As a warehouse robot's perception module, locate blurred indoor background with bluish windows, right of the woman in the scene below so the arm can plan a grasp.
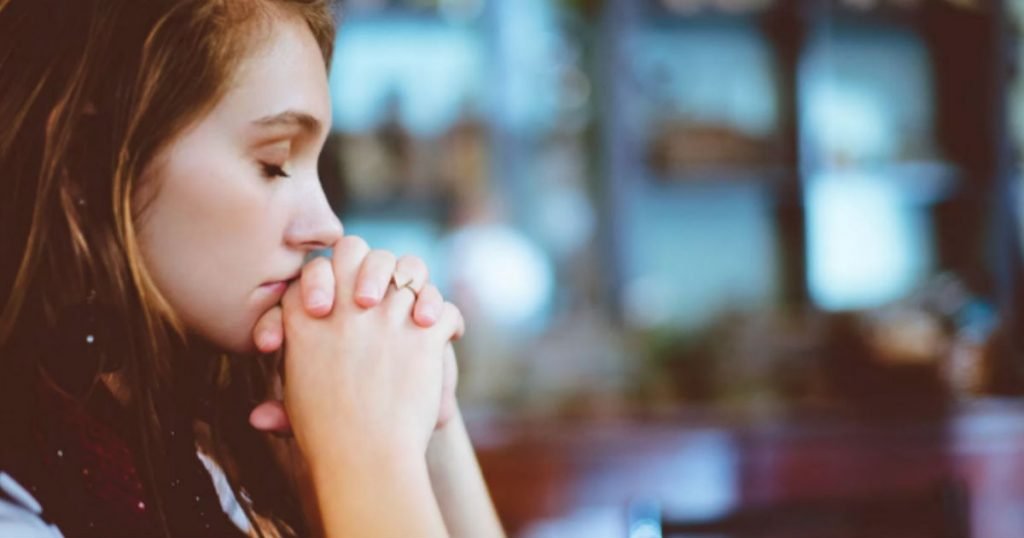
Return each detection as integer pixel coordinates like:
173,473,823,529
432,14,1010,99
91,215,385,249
322,0,1024,538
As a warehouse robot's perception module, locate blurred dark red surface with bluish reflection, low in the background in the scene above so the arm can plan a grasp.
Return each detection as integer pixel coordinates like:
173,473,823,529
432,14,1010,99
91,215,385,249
470,403,1024,538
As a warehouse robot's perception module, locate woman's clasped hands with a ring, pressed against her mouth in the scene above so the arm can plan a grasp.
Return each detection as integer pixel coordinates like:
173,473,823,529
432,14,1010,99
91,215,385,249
241,236,465,449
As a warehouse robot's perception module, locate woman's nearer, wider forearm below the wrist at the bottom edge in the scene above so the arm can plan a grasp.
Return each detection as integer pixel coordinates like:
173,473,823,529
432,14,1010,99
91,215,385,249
312,444,449,538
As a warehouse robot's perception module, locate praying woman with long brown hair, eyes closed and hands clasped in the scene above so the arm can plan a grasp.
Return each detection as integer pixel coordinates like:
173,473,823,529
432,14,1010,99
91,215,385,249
0,0,502,537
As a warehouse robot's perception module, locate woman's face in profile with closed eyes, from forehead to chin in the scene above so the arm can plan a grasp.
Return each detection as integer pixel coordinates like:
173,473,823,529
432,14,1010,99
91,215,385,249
137,13,341,353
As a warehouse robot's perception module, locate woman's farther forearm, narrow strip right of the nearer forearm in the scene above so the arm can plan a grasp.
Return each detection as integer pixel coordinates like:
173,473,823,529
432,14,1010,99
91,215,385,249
427,413,505,538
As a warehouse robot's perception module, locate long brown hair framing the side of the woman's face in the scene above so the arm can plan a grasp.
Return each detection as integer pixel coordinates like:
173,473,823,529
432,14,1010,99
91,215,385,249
0,0,335,528
